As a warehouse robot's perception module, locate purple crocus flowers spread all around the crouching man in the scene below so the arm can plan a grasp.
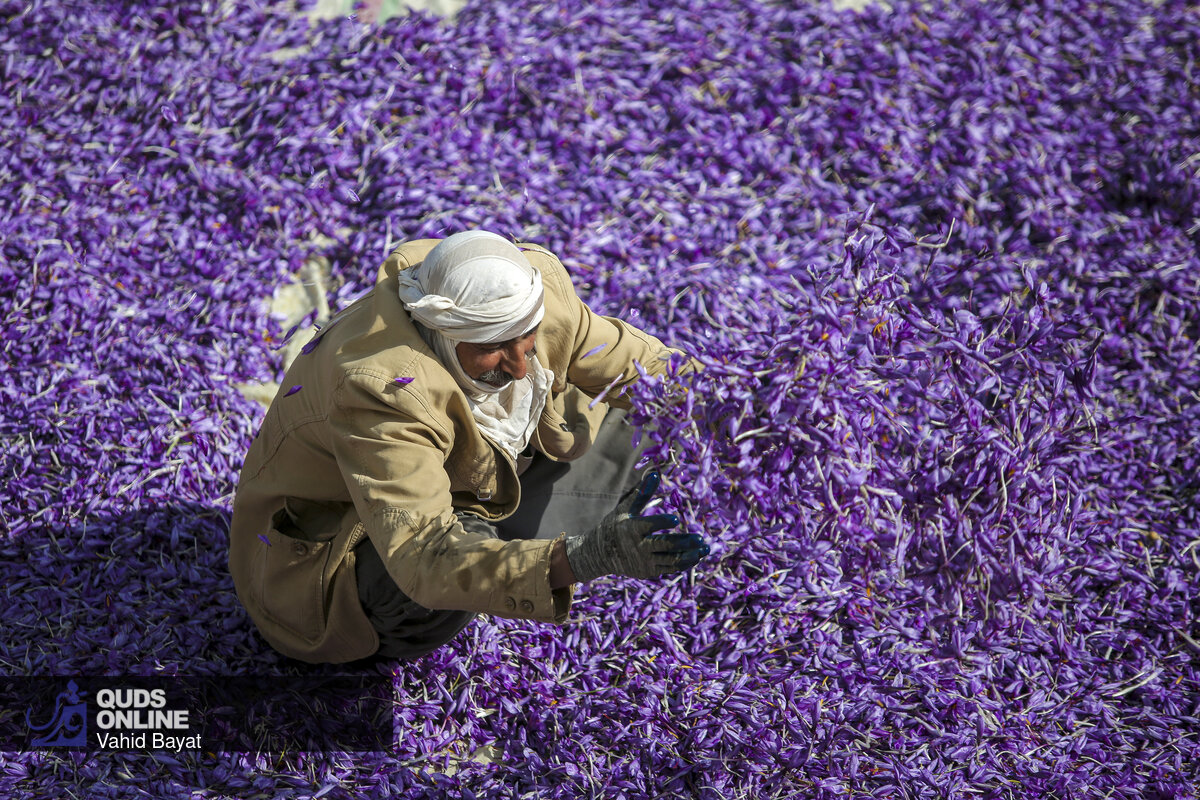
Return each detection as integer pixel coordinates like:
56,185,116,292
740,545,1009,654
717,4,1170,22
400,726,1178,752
0,0,1200,800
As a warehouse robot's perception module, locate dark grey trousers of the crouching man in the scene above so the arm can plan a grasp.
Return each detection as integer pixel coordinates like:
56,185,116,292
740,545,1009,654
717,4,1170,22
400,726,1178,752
354,409,642,660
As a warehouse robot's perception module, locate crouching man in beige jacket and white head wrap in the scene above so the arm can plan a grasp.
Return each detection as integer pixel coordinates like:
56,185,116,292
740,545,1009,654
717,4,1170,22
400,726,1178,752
229,230,708,662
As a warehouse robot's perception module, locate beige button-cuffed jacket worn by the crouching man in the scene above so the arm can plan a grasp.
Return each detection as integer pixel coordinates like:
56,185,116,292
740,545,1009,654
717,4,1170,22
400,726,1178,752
229,240,672,662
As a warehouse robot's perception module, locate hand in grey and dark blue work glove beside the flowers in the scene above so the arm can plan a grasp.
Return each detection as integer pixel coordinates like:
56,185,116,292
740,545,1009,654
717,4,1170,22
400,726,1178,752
566,470,708,581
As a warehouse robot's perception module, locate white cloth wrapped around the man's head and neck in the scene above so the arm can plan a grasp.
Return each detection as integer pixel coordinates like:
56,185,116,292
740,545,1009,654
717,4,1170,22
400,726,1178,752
400,230,554,459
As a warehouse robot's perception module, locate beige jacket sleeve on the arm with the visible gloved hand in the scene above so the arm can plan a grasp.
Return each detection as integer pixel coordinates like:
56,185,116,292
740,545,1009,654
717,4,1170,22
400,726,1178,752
330,372,571,622
